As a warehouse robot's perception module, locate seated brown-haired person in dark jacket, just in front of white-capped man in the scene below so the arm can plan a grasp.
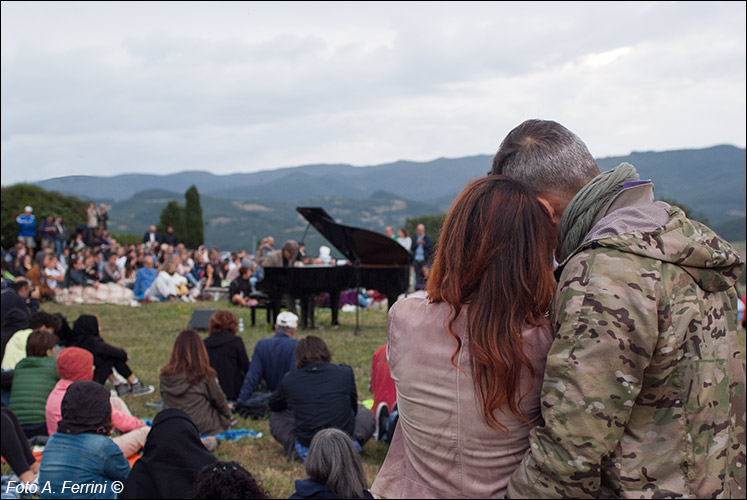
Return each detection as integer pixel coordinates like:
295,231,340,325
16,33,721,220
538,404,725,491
269,335,375,460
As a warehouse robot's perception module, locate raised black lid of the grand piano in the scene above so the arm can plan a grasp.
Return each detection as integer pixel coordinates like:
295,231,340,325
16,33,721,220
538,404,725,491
296,207,412,266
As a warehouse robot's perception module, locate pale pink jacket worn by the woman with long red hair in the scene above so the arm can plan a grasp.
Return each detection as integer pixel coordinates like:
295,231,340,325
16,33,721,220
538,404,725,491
371,295,552,498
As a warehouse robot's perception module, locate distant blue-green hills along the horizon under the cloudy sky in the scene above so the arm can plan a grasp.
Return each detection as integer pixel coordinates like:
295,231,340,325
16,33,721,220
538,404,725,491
23,146,747,252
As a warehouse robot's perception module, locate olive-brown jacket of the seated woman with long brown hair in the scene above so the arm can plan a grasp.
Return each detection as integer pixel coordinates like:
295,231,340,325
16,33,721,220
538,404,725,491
160,373,231,435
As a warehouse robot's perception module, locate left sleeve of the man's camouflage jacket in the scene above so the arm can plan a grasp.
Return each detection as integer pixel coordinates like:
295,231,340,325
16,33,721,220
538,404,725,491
507,249,660,498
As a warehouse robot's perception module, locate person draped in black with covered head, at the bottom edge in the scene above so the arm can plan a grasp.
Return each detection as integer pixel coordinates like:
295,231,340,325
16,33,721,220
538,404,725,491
119,408,218,499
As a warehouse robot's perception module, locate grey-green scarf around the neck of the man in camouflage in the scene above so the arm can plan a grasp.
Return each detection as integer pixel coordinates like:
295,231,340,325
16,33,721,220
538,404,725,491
557,162,638,262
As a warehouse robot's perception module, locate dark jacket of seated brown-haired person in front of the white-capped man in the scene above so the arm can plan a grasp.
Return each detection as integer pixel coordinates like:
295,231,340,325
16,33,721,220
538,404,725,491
269,362,358,446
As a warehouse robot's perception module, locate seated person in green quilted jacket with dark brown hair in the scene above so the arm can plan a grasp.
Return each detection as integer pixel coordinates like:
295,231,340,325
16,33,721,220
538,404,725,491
8,330,60,438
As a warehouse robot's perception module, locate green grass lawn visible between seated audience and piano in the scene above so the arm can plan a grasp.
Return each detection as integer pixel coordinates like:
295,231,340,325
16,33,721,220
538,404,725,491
36,302,387,498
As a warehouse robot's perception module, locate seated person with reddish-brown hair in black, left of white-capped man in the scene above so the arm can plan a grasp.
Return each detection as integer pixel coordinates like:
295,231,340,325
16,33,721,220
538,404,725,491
204,310,249,401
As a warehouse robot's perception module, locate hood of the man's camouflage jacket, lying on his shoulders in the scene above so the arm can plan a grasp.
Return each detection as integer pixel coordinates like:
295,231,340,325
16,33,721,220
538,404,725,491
574,203,744,292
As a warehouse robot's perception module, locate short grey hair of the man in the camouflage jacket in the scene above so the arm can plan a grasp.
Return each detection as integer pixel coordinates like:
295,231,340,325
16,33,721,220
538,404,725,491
489,120,599,197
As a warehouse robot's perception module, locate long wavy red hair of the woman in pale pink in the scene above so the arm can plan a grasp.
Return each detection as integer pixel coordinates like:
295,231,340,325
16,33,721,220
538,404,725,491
427,175,556,430
